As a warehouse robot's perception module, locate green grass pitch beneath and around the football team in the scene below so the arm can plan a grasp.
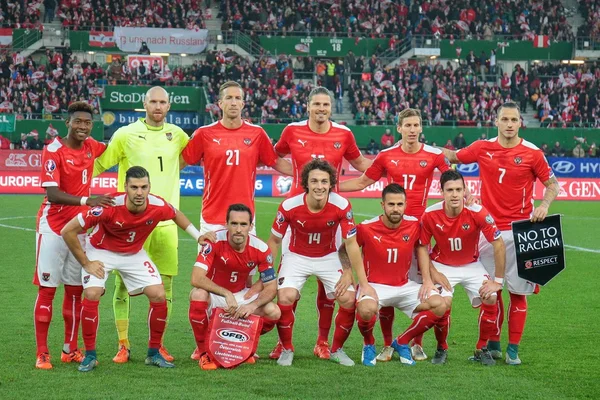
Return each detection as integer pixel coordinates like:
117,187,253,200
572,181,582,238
0,196,600,399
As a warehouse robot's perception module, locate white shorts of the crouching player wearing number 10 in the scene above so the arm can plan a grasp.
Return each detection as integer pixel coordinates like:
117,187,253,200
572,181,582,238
431,261,493,307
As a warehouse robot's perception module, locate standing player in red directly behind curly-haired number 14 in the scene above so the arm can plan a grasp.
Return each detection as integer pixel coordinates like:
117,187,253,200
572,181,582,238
270,87,371,359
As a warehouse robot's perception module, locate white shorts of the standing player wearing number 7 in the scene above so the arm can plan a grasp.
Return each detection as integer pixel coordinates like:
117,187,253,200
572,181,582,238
479,230,536,295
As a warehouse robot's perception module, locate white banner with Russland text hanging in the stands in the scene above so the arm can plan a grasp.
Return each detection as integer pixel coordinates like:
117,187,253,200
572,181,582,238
114,27,208,54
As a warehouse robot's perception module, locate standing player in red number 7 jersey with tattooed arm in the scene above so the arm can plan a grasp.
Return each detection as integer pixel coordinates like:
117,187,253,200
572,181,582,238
442,102,559,365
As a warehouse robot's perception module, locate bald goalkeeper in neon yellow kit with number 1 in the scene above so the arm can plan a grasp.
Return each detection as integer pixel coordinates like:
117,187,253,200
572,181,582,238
94,86,188,363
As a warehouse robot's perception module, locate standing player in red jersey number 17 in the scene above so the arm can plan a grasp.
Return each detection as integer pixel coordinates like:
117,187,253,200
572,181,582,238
340,108,450,361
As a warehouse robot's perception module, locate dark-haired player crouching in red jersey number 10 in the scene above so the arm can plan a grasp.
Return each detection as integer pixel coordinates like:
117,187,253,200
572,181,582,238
420,170,506,365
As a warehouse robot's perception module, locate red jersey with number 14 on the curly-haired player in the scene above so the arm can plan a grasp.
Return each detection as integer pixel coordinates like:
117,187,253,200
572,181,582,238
271,192,356,257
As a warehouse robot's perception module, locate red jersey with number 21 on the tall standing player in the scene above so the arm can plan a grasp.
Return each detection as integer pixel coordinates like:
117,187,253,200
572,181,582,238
181,121,278,225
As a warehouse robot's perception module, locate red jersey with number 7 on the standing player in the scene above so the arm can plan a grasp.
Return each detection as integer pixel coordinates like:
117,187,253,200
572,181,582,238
456,137,554,231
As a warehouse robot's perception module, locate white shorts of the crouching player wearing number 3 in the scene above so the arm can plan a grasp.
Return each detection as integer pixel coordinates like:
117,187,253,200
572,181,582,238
81,243,162,296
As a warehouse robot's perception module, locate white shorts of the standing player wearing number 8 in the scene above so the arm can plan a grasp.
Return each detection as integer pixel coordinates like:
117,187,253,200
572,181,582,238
35,232,85,287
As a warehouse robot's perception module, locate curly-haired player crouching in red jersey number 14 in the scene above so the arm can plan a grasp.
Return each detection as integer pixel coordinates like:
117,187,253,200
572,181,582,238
267,159,362,366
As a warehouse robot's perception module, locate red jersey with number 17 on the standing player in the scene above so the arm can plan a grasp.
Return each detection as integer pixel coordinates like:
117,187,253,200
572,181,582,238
365,144,450,217
